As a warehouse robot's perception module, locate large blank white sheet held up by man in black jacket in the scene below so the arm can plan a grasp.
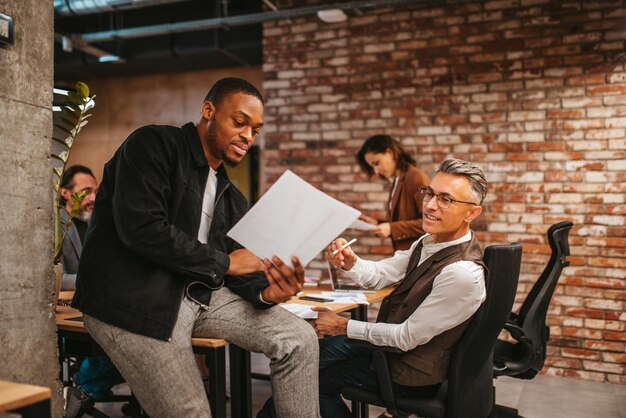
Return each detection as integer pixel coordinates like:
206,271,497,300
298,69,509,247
227,170,361,267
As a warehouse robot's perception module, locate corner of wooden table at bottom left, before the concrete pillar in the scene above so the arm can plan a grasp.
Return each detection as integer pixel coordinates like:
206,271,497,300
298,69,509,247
0,380,51,418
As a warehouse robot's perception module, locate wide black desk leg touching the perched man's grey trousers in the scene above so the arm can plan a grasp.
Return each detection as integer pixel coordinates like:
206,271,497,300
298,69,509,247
228,344,252,418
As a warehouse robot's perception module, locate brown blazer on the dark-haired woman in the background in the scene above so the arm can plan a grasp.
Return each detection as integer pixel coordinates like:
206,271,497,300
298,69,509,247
387,165,430,251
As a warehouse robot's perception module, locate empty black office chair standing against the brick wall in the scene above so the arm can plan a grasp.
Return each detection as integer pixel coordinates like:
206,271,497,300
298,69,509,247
493,222,573,379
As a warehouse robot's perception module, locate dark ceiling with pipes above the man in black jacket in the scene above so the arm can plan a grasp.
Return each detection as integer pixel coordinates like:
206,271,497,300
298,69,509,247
54,0,262,84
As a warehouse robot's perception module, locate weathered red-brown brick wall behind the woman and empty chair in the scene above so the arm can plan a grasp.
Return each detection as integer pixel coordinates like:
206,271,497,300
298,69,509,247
263,0,626,383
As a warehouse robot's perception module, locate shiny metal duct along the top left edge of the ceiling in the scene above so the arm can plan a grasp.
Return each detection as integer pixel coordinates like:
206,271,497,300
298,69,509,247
54,0,194,16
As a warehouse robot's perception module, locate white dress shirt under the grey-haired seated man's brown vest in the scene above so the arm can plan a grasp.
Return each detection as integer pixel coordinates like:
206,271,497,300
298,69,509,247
348,231,486,351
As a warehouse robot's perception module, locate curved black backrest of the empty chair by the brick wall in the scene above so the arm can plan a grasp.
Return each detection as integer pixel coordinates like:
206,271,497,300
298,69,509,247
517,221,573,371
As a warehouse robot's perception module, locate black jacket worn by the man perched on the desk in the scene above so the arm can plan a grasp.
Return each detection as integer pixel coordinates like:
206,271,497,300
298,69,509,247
72,123,271,340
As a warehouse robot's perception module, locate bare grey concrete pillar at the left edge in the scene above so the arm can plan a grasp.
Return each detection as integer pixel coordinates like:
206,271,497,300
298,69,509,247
0,0,62,417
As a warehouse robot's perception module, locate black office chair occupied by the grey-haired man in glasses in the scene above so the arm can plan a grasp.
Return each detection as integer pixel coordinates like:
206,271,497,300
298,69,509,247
341,243,522,418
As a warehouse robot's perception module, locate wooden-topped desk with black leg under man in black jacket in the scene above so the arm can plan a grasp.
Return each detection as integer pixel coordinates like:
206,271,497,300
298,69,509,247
56,304,229,418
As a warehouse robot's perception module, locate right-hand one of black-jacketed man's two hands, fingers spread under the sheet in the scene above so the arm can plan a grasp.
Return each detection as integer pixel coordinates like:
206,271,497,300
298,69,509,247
261,256,304,303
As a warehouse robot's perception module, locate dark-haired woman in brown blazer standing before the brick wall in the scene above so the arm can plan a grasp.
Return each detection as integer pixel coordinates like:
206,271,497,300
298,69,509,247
356,135,429,251
